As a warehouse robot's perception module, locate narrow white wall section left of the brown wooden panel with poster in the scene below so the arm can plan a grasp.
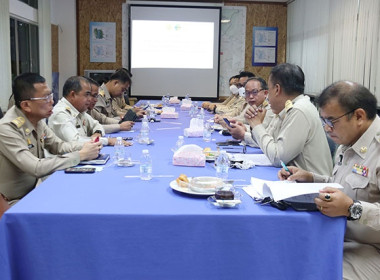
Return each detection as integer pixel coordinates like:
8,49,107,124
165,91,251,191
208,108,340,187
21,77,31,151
50,0,77,96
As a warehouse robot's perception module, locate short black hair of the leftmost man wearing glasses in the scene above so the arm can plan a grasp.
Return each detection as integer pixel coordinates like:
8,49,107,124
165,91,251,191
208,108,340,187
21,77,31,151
12,73,46,108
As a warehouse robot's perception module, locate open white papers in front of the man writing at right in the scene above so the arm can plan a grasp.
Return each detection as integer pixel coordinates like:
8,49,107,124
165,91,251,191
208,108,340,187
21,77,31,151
243,177,343,203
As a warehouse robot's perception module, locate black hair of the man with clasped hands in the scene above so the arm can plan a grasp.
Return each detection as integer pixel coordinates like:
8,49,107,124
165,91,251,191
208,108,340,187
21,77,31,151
269,63,305,95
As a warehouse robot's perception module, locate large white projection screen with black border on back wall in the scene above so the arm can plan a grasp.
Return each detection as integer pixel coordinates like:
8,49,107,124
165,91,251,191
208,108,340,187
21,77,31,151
129,4,221,99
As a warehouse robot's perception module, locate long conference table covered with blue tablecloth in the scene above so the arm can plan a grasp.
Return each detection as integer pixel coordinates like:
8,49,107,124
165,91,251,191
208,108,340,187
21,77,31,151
0,101,346,280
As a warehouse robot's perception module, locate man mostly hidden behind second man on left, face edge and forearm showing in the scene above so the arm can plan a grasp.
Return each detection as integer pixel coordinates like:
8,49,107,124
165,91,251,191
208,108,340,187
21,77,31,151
85,77,134,133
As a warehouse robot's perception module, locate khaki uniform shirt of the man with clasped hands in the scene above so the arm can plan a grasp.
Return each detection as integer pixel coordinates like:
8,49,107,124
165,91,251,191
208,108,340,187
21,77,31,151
252,95,332,175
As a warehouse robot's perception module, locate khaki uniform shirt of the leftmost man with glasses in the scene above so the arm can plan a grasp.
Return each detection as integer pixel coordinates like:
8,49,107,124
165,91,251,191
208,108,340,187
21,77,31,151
0,106,82,200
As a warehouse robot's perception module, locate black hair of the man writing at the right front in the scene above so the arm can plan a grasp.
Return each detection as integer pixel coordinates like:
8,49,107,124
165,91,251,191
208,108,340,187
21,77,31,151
317,81,377,120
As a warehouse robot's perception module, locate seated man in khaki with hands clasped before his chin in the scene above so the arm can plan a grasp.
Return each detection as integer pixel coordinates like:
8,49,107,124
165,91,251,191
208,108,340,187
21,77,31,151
245,63,332,175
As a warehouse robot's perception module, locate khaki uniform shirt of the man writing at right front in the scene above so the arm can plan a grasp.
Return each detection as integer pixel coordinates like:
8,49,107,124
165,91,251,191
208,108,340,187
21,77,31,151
313,116,380,249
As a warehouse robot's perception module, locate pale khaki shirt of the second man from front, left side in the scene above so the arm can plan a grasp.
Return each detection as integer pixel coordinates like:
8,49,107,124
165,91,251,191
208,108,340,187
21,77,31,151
49,97,108,145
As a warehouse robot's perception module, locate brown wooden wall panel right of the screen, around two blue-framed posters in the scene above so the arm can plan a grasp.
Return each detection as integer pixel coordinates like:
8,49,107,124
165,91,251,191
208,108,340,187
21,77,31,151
224,2,287,80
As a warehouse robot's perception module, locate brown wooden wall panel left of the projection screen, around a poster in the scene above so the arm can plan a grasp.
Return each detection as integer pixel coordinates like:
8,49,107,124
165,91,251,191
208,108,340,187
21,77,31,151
77,0,125,75
